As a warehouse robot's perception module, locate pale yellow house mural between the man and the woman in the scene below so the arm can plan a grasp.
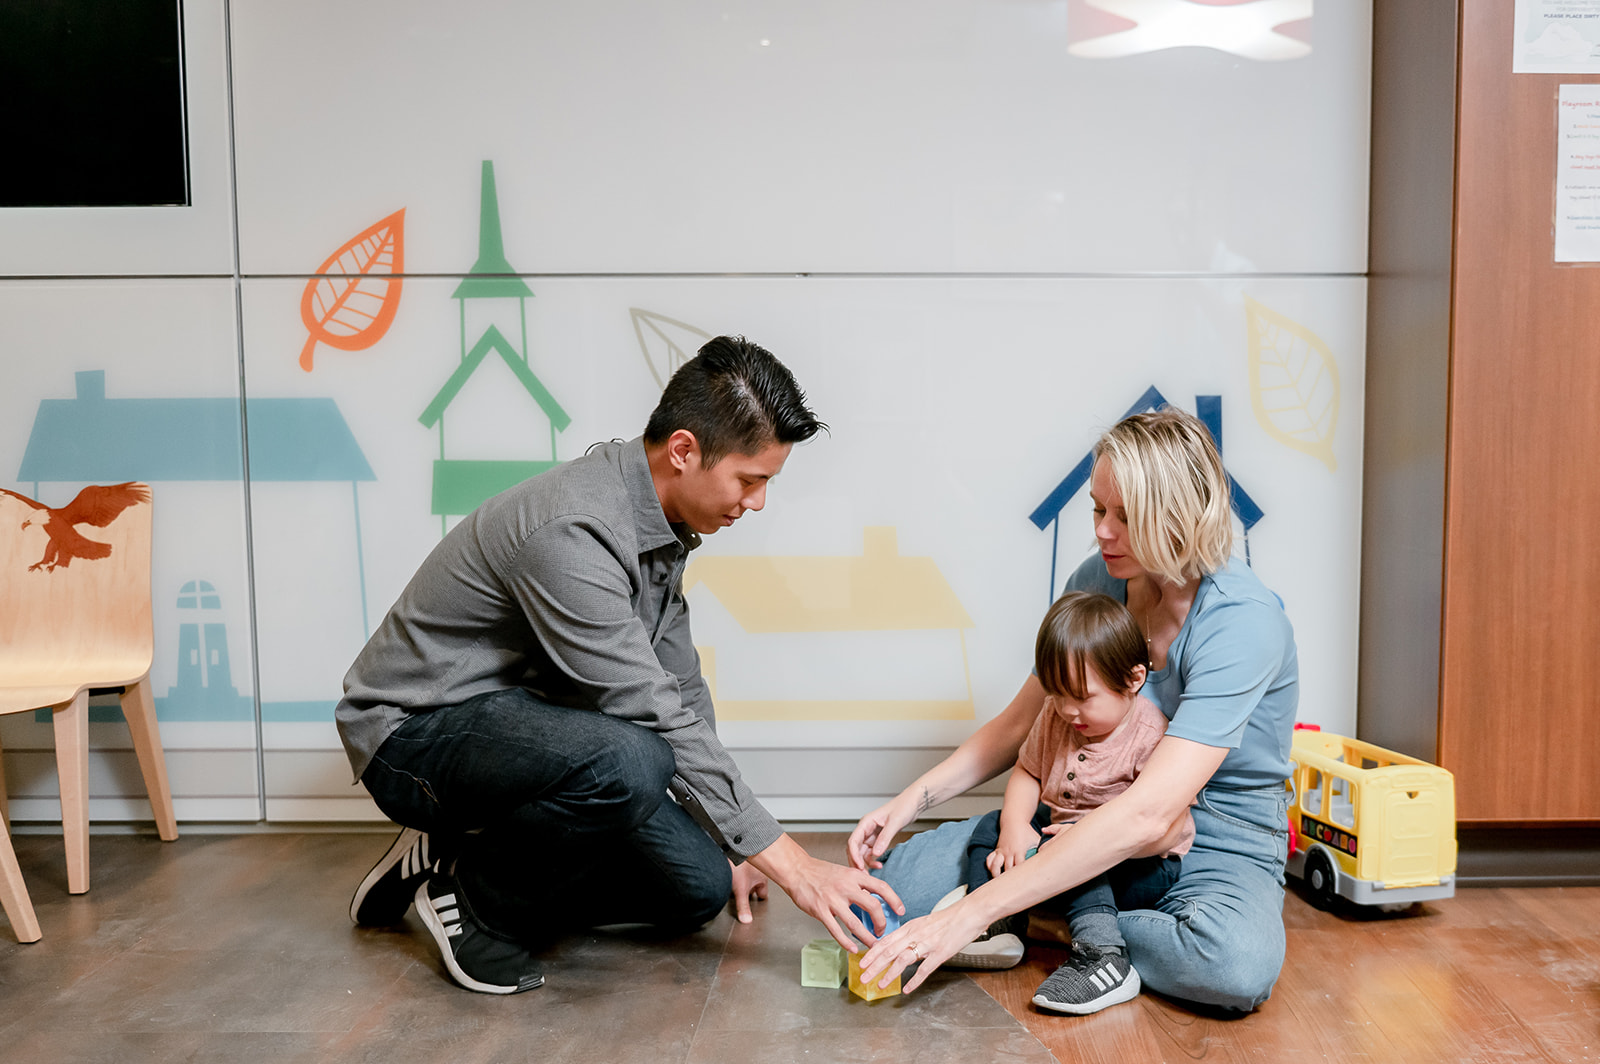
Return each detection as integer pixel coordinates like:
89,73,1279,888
683,528,976,720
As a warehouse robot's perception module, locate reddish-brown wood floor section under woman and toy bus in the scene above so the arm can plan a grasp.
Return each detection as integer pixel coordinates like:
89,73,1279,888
973,886,1600,1064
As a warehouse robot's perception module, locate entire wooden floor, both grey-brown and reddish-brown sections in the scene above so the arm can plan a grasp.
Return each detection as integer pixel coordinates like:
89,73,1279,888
0,834,1600,1064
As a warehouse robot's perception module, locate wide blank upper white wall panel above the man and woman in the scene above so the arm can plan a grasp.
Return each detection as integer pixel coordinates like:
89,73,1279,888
232,0,1371,274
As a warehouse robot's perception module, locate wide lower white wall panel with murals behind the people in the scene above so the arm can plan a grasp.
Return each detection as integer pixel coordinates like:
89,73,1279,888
243,270,1365,818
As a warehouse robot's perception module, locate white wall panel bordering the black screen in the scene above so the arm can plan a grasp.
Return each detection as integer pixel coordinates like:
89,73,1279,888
0,0,234,277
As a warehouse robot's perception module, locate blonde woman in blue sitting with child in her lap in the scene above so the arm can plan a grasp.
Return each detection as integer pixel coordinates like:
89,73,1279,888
850,408,1299,1011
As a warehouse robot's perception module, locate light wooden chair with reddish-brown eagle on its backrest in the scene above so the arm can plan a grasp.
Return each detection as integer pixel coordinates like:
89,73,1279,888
0,483,178,902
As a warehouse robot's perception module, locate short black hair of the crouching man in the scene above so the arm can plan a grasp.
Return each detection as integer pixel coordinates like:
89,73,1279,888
645,336,827,467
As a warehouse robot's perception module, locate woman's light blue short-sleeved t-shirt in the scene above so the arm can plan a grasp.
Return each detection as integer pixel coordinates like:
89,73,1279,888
1064,554,1299,787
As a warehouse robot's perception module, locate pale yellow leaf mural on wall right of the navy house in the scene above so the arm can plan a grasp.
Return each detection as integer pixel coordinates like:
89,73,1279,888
1245,296,1339,470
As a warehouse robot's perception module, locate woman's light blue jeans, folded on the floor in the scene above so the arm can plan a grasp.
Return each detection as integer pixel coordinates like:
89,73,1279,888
878,786,1290,1011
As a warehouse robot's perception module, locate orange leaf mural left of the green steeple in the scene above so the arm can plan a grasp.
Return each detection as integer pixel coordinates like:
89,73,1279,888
301,206,405,373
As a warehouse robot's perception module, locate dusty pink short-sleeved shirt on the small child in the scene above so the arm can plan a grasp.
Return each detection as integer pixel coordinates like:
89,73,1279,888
1016,696,1195,856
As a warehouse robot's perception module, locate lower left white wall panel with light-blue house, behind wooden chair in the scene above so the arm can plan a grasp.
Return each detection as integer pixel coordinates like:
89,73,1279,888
0,280,261,819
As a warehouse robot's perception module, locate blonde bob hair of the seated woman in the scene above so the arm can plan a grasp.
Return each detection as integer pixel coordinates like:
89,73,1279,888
1094,406,1234,584
